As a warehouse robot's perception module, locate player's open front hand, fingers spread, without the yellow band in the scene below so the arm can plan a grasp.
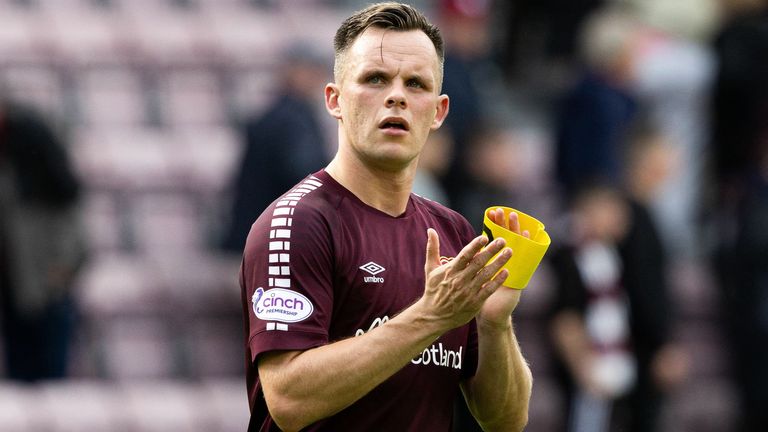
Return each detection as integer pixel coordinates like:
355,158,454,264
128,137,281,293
422,228,512,329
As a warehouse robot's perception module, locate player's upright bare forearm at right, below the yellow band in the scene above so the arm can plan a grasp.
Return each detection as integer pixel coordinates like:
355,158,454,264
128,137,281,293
463,319,533,431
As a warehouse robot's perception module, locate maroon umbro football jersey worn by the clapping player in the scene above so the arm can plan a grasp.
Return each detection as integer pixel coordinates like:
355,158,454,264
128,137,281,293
240,171,477,432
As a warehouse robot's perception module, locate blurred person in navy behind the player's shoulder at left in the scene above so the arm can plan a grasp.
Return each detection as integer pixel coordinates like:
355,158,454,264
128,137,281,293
223,43,328,253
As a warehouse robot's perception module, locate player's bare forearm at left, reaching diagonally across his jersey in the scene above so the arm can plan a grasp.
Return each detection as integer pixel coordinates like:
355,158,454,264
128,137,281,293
259,303,445,430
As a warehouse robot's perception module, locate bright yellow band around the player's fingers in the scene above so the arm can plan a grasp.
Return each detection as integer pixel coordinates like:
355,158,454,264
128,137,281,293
483,206,551,289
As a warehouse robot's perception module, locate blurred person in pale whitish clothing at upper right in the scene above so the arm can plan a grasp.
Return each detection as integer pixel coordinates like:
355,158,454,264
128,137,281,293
626,0,720,258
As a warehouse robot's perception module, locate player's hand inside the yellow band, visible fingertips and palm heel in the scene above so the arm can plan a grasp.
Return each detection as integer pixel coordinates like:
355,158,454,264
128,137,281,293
477,208,531,329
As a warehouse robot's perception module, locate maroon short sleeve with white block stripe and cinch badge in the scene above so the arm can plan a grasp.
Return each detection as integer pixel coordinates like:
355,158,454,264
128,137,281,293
240,197,333,361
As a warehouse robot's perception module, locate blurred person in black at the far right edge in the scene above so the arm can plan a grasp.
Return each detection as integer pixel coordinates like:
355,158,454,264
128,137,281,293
712,0,768,432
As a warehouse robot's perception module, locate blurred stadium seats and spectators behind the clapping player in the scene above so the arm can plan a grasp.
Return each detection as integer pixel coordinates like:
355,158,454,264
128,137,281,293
0,0,768,432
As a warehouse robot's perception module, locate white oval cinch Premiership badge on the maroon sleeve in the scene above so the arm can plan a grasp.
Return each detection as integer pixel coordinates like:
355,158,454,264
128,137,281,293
251,287,314,322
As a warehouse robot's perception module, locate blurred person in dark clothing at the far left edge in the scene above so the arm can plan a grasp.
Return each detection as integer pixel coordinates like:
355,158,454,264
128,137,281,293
0,102,85,382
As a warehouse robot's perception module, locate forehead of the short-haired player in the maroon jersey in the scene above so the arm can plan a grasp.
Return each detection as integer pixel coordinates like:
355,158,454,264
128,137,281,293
346,27,439,74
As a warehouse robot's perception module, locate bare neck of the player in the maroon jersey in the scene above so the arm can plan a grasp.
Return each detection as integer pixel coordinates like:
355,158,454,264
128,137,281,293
325,154,416,217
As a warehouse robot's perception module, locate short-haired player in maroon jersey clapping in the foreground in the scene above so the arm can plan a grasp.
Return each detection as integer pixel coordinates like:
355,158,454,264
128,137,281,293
240,3,532,431
